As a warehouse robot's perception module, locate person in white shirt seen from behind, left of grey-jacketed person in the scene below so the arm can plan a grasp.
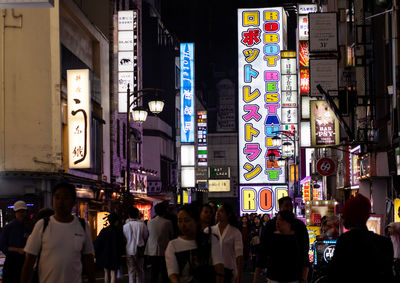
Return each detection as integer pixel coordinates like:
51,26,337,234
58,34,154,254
123,207,149,283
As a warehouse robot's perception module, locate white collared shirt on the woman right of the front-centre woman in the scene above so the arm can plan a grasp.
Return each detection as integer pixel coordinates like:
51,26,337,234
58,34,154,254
211,224,243,273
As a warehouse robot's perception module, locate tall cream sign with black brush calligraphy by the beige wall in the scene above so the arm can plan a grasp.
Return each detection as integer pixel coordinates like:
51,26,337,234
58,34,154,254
67,69,92,168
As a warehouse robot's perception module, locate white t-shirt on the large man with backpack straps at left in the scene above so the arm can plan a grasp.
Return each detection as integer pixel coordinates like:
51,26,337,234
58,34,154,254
24,216,94,283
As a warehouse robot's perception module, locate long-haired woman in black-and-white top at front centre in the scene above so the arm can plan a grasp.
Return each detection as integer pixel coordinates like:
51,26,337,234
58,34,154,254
165,205,224,283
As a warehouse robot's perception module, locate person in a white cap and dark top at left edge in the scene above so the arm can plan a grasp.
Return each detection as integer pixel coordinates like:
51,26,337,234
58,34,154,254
0,200,30,283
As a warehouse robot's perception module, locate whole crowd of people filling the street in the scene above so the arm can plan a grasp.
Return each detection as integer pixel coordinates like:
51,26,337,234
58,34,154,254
0,183,400,283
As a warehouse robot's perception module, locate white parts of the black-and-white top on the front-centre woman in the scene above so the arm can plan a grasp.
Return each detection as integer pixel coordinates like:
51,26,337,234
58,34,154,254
165,236,223,282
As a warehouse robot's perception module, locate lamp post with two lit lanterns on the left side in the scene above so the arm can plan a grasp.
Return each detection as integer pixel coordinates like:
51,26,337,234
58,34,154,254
125,84,164,192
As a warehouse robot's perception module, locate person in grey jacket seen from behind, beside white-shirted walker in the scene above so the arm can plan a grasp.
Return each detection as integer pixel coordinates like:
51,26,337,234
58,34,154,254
144,202,174,283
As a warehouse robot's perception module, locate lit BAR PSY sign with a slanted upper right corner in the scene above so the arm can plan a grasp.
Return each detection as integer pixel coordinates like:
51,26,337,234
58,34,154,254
310,100,340,147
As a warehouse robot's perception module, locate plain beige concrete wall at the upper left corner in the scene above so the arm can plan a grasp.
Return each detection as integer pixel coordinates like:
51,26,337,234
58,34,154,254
0,1,62,171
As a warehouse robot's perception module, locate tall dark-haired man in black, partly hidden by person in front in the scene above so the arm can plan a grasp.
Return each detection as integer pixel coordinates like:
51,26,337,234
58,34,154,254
253,196,310,283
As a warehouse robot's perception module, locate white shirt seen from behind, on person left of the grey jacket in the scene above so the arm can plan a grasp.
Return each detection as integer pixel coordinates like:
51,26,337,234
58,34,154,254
123,219,149,255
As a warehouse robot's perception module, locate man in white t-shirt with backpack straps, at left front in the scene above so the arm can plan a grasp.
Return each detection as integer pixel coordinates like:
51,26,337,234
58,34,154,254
21,183,96,283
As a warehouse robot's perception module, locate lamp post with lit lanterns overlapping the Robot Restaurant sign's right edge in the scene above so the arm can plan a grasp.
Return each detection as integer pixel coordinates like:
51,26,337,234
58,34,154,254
272,131,299,197
